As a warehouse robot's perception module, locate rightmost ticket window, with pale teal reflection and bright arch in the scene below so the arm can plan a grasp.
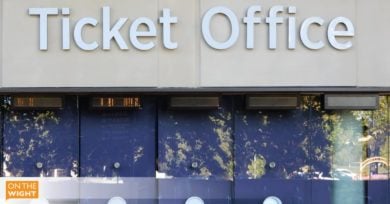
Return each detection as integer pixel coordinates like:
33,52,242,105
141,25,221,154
322,96,389,204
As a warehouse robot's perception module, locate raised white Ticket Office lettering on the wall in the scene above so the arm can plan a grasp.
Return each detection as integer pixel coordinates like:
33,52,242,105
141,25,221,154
28,5,355,51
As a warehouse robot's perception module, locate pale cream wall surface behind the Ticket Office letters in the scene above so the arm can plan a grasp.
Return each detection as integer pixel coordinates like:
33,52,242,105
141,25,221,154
0,0,390,87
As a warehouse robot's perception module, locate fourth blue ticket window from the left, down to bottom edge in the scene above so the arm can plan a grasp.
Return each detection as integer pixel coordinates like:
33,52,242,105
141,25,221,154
234,96,314,204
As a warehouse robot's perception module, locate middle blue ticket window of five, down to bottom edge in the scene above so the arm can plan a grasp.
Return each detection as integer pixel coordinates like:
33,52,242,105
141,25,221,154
157,97,233,204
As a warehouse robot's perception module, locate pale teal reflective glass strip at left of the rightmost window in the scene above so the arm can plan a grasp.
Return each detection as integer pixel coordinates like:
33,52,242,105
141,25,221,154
323,111,364,204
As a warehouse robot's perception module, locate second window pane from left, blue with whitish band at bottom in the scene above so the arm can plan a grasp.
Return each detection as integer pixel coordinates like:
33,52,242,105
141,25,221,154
80,97,157,204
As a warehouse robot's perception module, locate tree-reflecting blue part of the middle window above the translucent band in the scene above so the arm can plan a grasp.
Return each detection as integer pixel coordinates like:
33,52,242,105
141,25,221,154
158,100,233,179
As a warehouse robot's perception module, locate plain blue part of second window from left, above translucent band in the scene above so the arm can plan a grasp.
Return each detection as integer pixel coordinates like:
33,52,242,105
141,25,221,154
80,97,156,177
